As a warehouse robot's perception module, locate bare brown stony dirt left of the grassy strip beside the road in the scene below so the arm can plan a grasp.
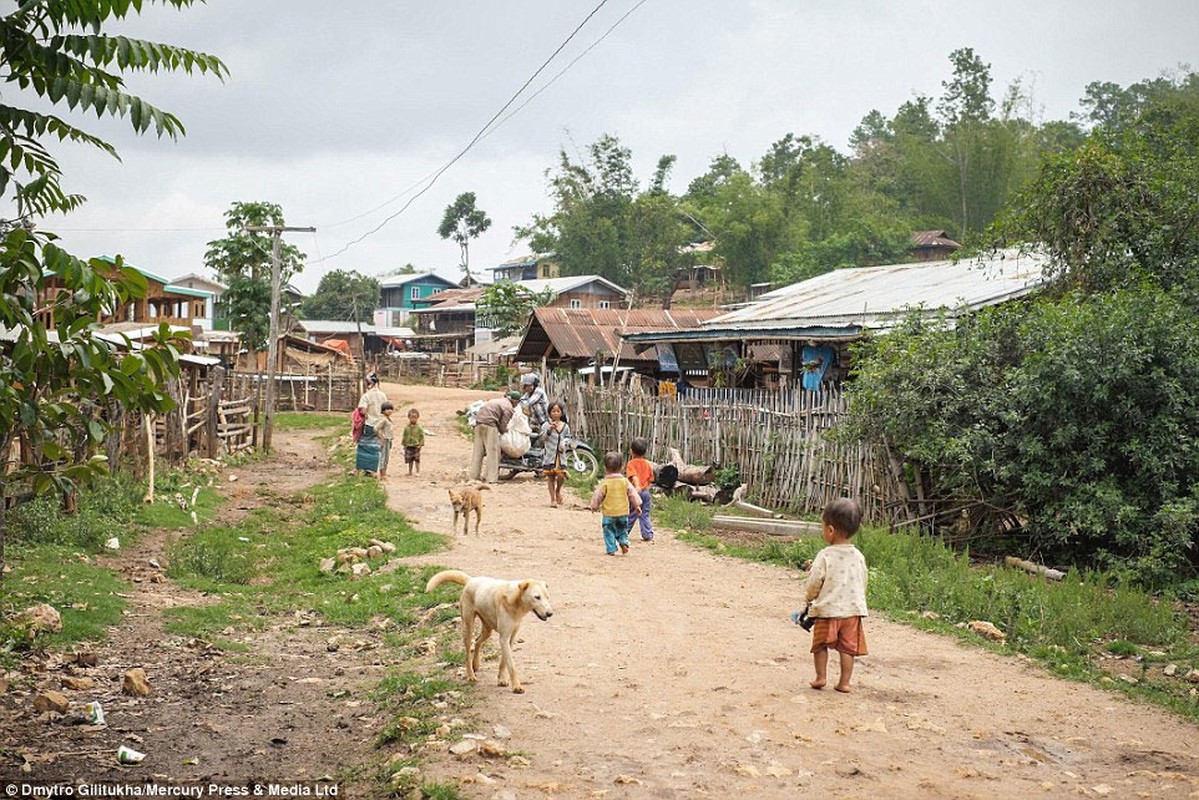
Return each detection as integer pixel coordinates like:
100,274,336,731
0,432,386,796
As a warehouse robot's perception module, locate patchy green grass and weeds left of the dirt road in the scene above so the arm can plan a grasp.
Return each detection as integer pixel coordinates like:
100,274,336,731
0,422,471,800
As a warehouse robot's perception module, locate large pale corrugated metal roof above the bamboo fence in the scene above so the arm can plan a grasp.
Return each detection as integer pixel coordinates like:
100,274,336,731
706,251,1047,331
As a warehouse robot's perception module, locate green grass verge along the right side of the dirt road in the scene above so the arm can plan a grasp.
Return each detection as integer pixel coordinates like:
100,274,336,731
676,498,1199,720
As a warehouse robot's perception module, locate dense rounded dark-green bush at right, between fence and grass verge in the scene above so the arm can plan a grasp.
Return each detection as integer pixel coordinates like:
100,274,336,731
839,281,1199,588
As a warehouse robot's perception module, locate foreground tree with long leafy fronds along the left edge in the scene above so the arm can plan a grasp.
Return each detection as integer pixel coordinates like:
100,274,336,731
0,0,227,576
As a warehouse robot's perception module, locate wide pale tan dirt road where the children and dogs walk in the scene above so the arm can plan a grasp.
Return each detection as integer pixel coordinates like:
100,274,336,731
385,386,1199,800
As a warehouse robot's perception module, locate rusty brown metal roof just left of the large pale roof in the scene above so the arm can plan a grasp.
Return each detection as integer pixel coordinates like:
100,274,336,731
517,307,721,361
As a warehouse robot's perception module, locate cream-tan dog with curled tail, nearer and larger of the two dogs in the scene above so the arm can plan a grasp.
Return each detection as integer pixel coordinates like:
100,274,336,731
424,570,554,694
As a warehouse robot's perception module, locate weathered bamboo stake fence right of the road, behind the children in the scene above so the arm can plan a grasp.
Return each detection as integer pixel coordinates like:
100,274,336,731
547,373,911,523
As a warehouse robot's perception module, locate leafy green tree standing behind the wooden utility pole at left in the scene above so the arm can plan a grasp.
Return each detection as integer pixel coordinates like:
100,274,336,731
204,203,307,353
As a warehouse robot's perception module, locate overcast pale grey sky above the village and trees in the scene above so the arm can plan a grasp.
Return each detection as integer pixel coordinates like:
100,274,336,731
16,0,1199,291
